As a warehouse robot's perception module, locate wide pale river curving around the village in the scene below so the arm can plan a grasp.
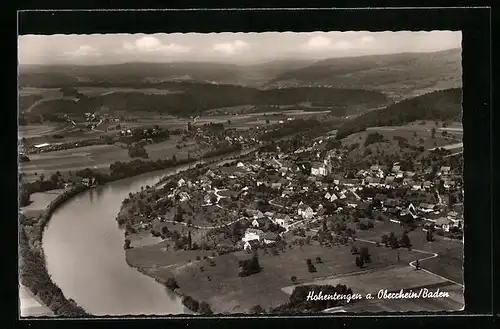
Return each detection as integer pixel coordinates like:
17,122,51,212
43,150,251,316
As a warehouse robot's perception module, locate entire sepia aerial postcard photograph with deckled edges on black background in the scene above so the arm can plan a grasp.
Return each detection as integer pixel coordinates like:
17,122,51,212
17,30,464,318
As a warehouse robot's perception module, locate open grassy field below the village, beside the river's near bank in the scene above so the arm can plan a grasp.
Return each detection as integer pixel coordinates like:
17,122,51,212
127,234,423,313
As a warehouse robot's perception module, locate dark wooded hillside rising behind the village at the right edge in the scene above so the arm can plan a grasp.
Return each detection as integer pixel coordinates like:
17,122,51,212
337,88,462,139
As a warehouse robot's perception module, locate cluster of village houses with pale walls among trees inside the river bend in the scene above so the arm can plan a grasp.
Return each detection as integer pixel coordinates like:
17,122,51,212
122,131,463,249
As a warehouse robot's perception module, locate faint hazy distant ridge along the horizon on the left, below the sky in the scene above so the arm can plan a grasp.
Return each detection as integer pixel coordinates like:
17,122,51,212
19,59,313,87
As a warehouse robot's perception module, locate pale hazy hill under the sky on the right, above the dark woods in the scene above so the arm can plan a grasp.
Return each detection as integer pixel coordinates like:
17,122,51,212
267,49,462,100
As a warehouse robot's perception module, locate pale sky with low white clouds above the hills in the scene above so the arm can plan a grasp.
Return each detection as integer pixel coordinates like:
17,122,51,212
18,31,462,65
